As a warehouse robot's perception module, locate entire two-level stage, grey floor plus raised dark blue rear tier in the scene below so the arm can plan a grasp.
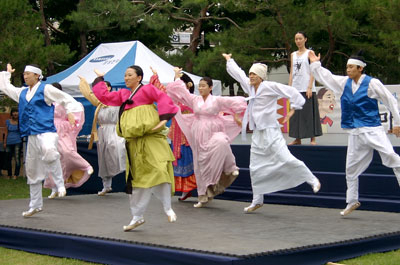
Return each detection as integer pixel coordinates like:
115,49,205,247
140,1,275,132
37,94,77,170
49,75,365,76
0,134,400,265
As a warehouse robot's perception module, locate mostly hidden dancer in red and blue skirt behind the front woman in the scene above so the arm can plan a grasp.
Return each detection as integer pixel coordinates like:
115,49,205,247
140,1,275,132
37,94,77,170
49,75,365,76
150,68,197,201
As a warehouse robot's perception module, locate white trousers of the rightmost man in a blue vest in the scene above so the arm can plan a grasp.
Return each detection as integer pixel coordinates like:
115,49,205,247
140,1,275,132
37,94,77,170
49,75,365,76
346,128,400,203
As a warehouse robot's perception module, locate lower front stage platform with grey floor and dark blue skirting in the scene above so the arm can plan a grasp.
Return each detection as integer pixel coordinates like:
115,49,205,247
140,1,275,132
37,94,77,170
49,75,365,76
0,193,400,265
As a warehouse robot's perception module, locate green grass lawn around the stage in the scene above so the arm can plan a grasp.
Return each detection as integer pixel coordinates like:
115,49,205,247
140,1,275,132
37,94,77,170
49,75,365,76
0,174,400,265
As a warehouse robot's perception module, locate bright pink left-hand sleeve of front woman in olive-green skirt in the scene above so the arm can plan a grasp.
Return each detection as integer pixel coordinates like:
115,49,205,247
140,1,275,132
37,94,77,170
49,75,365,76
92,77,125,106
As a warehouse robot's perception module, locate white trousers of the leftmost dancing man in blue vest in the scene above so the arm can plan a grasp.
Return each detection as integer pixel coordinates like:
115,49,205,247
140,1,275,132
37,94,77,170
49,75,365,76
25,132,64,208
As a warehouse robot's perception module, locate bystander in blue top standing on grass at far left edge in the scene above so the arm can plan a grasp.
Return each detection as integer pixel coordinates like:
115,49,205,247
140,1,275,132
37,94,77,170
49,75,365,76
3,109,22,179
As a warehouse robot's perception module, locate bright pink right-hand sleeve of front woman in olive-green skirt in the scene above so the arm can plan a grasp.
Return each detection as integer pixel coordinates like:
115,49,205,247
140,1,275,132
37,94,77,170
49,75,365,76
143,85,179,121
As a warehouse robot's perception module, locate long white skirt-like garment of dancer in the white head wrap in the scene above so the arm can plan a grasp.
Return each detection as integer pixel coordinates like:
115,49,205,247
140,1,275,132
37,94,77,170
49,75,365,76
250,128,318,200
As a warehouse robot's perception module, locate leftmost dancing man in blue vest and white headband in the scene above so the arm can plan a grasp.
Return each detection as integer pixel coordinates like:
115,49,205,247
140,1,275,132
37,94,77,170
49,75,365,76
0,64,83,217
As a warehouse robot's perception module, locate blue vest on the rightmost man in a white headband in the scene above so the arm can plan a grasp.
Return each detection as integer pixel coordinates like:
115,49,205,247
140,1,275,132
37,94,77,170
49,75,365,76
341,75,381,129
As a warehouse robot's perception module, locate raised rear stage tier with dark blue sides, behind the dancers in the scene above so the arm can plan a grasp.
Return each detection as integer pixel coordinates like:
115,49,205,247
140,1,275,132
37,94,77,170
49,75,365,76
69,134,400,212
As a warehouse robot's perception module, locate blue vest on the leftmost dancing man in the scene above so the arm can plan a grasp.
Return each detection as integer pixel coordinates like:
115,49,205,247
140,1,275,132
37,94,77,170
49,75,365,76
18,83,57,137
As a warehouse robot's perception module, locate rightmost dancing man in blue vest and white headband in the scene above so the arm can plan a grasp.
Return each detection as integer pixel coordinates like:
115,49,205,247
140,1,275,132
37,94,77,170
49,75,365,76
309,52,400,216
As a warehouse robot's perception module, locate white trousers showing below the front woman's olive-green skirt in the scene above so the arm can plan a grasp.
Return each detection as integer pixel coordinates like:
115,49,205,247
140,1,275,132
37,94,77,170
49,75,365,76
129,183,172,219
